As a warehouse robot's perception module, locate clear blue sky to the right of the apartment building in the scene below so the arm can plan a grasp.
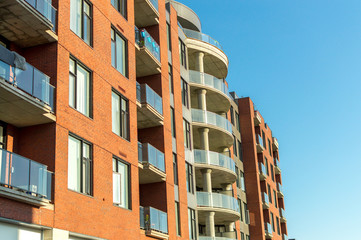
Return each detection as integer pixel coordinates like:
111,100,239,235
180,0,361,240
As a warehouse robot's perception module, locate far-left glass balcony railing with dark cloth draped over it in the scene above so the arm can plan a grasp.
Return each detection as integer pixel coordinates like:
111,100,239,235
0,58,55,111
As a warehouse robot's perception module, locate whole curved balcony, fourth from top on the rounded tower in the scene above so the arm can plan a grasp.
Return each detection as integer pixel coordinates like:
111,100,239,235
193,149,237,188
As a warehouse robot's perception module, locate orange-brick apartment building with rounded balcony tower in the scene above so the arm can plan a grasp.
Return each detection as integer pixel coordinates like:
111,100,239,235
0,0,287,240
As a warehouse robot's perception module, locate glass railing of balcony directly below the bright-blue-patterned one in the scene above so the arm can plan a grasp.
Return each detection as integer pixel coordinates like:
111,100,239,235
137,83,163,115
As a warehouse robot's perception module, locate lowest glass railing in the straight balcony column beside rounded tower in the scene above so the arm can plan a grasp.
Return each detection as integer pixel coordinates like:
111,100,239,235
140,206,168,234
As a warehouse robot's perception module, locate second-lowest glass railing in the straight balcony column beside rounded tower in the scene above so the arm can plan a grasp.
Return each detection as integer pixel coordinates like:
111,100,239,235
138,142,165,172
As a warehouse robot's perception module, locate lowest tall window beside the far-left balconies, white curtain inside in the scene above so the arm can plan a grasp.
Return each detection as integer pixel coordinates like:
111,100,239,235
68,135,93,195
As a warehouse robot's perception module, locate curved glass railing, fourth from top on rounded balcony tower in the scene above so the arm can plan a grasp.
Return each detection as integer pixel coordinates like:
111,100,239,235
193,149,236,172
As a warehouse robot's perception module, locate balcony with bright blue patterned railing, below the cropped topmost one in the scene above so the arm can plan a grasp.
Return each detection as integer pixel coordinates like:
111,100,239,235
135,27,161,77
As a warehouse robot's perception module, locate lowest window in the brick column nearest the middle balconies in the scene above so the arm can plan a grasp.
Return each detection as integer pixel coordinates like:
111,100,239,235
113,157,130,209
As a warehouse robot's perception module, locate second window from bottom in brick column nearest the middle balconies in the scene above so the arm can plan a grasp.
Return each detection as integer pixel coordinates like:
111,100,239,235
112,90,129,140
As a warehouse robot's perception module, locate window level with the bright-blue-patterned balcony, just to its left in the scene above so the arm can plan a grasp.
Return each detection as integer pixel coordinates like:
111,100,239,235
111,28,128,77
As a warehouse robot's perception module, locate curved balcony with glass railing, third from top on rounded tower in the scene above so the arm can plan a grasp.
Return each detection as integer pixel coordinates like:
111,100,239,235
192,109,233,151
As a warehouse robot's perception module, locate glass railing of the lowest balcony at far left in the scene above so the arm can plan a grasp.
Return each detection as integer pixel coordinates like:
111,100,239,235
0,149,52,200
